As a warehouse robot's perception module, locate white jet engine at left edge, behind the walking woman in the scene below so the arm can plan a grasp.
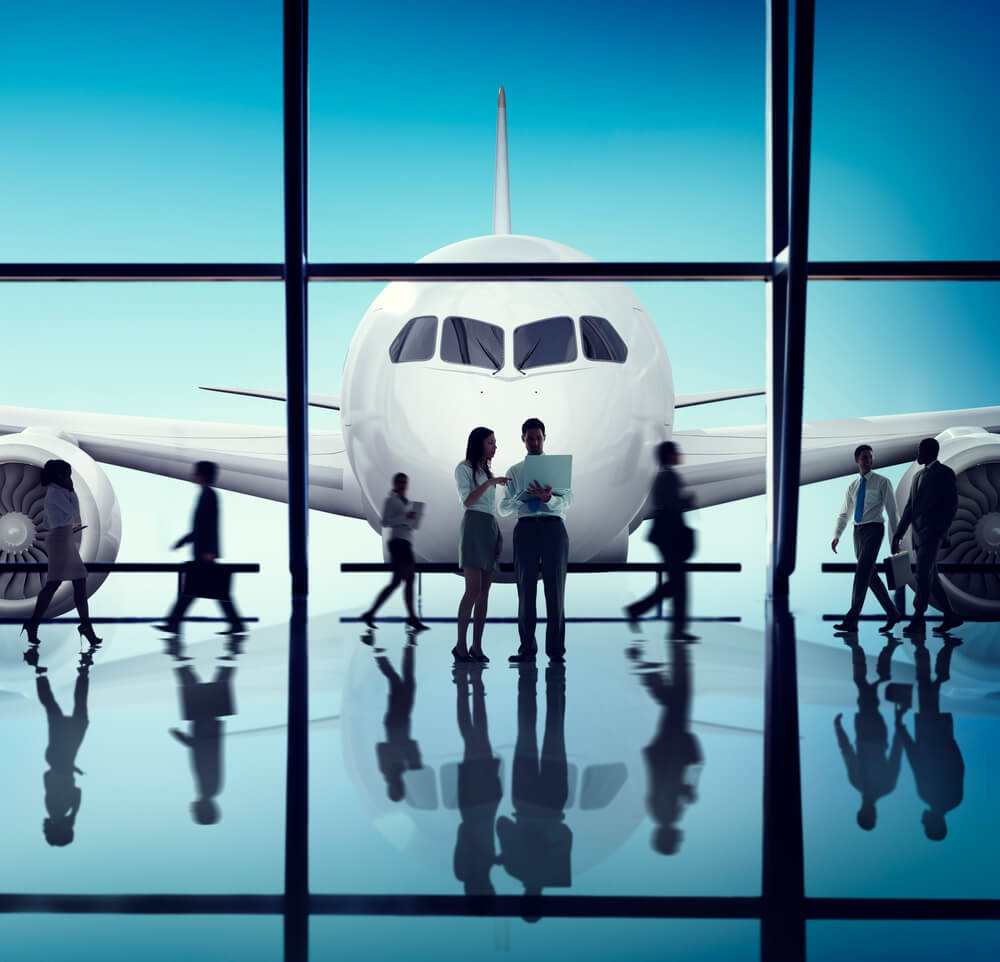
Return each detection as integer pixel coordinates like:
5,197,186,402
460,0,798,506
0,428,122,620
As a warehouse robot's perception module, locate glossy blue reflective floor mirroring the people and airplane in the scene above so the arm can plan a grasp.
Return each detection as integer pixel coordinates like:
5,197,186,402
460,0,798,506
0,588,1000,960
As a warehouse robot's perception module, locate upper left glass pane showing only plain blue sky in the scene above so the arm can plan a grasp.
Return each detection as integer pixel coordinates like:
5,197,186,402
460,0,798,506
0,0,283,262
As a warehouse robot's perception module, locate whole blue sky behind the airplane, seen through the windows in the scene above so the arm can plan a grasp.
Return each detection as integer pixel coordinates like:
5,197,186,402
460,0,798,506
0,0,1000,628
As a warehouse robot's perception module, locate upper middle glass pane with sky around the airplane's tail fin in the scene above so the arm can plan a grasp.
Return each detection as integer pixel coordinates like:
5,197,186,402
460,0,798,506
309,0,765,258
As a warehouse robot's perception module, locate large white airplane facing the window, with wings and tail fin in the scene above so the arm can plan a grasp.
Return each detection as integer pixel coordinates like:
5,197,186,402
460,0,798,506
0,90,1000,617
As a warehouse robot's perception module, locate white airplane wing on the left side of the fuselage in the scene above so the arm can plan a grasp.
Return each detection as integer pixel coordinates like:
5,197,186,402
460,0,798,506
0,407,365,518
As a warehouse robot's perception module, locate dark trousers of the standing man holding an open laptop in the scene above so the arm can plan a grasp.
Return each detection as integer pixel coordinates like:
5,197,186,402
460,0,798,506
514,515,569,658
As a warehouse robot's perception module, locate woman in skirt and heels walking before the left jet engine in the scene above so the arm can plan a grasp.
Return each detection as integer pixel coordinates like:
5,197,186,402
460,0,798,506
22,461,102,645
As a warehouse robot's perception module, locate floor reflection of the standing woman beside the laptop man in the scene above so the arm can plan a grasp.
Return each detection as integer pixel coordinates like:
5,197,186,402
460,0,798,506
454,666,503,895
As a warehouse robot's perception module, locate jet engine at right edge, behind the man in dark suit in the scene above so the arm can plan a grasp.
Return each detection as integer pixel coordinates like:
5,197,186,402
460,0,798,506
896,427,1000,621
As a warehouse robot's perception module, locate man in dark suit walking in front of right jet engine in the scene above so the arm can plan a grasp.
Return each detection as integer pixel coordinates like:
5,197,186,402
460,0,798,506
892,438,962,635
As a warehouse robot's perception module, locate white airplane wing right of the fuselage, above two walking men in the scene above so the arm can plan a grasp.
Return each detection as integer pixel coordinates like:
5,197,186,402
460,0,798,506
664,407,1000,517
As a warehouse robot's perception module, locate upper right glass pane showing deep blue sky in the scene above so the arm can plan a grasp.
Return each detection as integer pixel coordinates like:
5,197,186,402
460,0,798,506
809,0,1000,260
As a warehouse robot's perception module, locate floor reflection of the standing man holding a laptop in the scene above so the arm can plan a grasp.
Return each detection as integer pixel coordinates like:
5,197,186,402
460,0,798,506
497,664,573,922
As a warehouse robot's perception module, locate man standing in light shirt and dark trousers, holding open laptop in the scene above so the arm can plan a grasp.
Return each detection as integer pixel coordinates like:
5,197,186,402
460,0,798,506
497,418,573,663
